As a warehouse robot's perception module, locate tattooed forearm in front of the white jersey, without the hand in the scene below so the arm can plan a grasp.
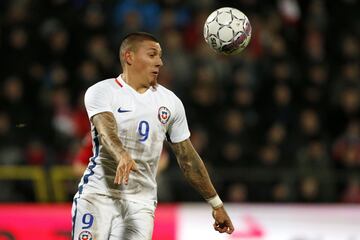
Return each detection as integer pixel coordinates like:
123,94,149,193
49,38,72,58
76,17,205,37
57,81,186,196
92,112,125,161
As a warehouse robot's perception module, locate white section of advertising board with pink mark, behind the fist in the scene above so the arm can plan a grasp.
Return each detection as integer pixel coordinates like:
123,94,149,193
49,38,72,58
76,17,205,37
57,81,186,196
177,204,360,240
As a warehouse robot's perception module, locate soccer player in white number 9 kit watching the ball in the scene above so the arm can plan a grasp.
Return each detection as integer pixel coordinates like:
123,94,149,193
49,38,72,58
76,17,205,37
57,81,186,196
72,32,234,240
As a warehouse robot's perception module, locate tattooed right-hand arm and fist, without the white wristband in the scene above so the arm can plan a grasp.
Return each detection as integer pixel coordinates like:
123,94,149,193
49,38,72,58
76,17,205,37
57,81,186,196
171,139,234,234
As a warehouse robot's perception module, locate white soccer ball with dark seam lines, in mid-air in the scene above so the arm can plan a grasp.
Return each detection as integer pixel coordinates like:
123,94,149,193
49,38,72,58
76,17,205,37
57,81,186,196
204,7,251,55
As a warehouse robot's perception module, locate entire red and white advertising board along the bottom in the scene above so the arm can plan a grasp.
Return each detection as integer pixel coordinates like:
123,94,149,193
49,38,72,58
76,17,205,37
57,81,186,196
0,204,360,240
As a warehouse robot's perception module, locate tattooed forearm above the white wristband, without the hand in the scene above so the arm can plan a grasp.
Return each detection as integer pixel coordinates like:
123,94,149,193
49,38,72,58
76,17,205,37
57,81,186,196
172,140,216,199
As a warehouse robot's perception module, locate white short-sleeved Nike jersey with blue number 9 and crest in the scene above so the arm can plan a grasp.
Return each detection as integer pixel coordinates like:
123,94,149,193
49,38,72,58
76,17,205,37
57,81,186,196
77,76,190,204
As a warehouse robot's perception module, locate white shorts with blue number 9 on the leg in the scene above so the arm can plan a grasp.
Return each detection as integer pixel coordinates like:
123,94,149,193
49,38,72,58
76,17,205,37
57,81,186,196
72,194,155,240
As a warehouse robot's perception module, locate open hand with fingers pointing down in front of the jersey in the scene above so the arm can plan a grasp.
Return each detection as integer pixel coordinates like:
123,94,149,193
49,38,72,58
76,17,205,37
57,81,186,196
114,151,138,185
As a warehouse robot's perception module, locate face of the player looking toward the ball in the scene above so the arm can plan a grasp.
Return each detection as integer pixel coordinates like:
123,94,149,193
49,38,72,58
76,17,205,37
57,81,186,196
133,40,163,87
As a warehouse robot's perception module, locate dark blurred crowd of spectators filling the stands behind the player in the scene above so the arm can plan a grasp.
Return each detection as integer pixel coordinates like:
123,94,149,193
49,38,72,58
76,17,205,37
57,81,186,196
0,0,360,203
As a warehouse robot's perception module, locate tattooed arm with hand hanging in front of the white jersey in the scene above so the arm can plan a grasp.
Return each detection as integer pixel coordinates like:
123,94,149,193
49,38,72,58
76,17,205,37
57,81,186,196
91,112,137,184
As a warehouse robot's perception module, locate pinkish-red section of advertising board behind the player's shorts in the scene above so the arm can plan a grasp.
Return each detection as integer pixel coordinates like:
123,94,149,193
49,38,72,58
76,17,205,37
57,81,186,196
0,204,178,240
